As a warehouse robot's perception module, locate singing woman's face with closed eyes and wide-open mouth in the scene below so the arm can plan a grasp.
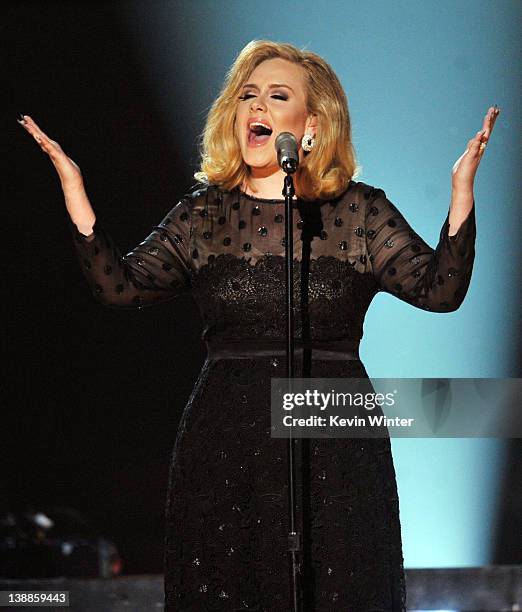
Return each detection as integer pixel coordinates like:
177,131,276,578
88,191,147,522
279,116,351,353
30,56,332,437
235,58,316,177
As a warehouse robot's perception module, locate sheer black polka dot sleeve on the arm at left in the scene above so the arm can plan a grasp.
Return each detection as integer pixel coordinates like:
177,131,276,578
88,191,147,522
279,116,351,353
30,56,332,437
69,199,192,309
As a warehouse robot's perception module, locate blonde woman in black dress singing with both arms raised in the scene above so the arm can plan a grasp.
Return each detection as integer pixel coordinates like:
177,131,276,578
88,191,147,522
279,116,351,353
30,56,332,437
20,41,499,612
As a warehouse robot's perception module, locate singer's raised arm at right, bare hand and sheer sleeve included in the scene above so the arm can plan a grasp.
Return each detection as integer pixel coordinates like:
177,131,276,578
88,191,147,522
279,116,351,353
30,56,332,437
365,106,500,312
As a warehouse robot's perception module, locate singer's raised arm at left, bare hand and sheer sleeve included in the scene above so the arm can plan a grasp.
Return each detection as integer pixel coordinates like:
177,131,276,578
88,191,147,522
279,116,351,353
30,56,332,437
18,115,192,308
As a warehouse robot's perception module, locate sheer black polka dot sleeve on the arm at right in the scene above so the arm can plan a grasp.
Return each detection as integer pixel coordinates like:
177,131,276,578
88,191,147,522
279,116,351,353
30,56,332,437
366,188,476,312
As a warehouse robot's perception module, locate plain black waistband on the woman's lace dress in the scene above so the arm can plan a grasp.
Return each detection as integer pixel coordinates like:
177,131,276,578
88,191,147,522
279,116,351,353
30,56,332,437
206,340,359,361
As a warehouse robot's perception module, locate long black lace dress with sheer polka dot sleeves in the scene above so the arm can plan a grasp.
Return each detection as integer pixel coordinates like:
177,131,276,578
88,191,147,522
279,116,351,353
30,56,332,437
71,181,476,612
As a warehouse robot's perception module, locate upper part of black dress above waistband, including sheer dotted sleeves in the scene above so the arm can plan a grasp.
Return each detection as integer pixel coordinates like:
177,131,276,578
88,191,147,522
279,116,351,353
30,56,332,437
67,182,476,341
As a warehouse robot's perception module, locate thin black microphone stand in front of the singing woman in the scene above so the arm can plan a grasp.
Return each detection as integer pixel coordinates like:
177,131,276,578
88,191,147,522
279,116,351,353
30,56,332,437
283,169,302,612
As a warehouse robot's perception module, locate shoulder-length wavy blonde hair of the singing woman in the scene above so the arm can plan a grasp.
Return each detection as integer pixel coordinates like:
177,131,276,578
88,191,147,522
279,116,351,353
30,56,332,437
194,40,359,200
